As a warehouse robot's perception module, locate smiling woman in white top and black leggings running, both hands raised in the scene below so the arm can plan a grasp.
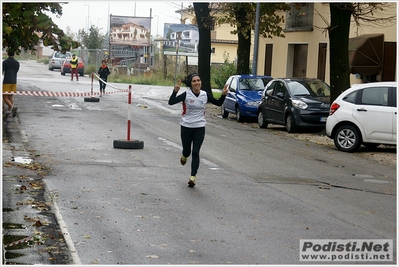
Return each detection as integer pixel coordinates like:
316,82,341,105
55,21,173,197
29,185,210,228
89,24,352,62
168,73,228,187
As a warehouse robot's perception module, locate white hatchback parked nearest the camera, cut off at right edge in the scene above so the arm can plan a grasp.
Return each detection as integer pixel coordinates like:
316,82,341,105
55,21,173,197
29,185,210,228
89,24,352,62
326,82,397,152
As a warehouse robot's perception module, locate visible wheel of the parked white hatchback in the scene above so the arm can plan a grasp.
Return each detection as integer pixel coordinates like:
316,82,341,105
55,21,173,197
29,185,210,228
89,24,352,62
334,125,362,152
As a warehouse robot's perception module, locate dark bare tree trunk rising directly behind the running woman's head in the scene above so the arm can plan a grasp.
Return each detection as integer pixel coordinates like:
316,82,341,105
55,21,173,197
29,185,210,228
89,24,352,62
194,3,212,93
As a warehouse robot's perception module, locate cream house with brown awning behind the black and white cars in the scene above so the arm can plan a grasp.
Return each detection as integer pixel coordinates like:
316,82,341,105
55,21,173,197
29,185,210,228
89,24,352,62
257,2,397,84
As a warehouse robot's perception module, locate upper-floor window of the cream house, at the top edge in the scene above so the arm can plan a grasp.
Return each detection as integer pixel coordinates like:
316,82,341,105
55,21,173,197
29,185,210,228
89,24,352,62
285,3,314,31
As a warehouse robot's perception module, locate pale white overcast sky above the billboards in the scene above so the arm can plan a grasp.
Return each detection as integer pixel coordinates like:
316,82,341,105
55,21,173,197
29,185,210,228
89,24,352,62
51,0,192,36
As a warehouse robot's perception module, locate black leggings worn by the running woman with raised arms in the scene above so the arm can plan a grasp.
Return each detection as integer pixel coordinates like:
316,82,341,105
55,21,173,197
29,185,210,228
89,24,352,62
180,126,205,176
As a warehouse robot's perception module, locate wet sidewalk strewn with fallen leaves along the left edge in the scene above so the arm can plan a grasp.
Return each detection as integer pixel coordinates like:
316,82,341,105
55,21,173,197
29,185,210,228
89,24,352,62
2,109,73,265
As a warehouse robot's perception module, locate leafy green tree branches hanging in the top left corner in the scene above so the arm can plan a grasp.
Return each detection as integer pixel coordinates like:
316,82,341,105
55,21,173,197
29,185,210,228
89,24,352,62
2,2,80,54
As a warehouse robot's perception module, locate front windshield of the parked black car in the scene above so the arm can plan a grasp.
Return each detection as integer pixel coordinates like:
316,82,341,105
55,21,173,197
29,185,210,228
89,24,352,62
289,81,330,97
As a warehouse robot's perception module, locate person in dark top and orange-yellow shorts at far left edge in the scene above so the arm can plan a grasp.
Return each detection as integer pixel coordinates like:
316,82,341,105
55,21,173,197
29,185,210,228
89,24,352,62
3,51,19,117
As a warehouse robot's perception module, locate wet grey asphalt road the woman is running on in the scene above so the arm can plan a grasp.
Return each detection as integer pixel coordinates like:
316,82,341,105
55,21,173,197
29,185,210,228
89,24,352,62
2,60,396,264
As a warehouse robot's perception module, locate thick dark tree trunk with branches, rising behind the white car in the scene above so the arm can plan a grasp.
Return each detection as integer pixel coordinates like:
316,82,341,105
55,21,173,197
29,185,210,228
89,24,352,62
327,2,396,101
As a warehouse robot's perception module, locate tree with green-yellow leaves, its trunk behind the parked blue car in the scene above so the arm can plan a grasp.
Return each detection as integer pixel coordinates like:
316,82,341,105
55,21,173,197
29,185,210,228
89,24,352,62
215,2,289,74
